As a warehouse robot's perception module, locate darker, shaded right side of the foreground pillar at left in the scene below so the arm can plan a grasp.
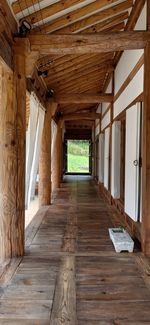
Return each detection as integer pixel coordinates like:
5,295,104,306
13,43,27,256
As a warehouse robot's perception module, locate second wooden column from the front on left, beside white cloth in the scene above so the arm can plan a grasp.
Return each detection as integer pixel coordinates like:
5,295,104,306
39,103,52,206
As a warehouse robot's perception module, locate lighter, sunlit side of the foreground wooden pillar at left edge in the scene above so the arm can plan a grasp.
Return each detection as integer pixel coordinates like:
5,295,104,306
0,65,17,260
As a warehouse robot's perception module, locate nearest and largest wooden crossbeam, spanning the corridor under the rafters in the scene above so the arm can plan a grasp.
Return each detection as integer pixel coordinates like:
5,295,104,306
27,31,150,55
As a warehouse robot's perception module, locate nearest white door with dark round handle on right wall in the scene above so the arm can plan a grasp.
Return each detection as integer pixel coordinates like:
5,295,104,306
125,104,141,221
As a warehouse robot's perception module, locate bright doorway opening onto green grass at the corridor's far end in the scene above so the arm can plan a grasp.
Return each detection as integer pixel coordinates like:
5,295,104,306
66,140,92,174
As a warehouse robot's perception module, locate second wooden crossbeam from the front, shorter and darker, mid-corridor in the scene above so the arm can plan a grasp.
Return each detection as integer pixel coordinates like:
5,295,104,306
54,93,114,104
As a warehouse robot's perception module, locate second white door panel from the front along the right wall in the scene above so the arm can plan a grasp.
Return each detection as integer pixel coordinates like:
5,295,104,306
111,121,121,199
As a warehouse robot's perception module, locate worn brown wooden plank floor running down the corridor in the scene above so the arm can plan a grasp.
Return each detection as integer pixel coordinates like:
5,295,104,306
0,177,150,325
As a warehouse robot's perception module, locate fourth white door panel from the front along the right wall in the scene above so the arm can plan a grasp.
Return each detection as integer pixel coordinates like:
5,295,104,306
99,133,104,183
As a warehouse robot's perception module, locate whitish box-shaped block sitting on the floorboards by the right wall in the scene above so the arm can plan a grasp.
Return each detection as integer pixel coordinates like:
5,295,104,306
109,228,134,253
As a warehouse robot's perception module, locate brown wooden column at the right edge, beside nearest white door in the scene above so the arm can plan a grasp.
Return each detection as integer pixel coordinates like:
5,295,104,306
141,42,150,256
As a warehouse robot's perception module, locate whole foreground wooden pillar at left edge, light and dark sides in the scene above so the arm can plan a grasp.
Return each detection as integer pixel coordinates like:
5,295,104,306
0,44,26,260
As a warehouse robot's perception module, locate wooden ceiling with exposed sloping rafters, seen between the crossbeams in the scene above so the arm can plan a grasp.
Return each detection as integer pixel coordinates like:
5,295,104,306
8,0,145,126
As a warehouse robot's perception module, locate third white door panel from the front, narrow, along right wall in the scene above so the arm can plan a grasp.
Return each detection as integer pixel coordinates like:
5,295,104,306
104,127,110,190
